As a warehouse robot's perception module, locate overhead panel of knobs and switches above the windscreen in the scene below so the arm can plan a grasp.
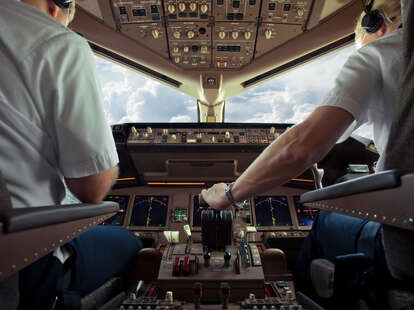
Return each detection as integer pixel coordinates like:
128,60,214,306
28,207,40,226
108,0,312,70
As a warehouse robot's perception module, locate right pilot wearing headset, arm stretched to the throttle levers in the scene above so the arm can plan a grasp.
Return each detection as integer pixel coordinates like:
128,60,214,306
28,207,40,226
201,0,403,302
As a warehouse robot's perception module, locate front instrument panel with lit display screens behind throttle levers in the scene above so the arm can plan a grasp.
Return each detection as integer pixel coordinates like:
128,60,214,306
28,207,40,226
105,186,319,243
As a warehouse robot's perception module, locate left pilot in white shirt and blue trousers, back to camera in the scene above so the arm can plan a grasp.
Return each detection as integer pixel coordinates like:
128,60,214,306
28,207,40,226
0,0,142,309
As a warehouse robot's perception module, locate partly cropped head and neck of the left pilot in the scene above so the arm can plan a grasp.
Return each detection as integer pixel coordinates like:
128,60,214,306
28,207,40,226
21,0,75,26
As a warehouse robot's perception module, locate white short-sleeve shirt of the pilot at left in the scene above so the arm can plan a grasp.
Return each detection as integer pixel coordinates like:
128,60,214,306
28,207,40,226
0,0,118,208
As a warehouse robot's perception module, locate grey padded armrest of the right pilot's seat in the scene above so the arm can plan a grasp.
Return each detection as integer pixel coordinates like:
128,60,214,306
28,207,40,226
300,170,414,203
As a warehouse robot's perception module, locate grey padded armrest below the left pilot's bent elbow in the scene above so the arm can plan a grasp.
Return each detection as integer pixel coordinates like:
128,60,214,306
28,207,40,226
0,201,119,234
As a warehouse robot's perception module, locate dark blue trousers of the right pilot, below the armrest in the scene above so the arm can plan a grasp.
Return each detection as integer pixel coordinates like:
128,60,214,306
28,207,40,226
295,211,386,294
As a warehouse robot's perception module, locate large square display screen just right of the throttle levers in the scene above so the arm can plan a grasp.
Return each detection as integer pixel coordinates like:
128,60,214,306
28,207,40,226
254,196,292,227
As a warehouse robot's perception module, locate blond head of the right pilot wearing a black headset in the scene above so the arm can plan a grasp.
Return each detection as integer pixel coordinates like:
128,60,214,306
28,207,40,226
355,0,402,47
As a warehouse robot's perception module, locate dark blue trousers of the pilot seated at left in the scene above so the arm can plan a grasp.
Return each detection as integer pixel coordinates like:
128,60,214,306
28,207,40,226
19,226,142,309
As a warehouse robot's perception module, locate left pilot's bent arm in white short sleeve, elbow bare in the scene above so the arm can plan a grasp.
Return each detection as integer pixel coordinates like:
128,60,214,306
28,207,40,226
42,33,118,203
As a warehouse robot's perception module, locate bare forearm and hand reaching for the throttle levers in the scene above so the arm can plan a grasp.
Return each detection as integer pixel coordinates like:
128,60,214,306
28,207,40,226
201,106,354,209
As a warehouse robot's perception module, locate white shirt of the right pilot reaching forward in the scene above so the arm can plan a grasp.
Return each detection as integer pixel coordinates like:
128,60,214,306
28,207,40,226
321,29,403,165
